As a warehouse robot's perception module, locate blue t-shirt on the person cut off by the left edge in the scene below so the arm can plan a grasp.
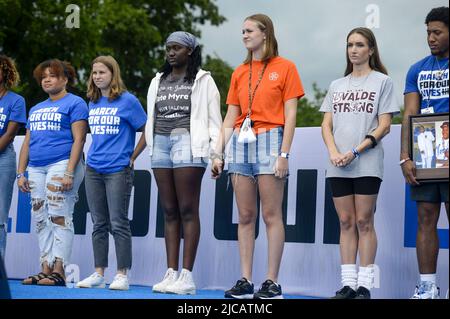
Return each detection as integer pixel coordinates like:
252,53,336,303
0,91,27,137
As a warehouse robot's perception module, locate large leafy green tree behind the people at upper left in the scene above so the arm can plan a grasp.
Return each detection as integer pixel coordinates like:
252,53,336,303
0,0,225,107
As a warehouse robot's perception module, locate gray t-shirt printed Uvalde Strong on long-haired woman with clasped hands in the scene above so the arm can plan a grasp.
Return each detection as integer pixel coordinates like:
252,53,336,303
320,71,400,179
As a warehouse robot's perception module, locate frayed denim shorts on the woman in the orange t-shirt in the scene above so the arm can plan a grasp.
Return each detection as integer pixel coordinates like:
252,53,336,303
227,127,283,177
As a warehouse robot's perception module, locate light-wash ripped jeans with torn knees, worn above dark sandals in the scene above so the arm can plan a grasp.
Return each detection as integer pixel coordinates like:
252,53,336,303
28,159,84,267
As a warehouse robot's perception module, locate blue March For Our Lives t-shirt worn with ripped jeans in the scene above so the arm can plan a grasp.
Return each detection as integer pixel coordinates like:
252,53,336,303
27,93,88,167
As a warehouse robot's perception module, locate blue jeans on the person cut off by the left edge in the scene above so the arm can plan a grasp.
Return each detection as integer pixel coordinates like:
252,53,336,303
0,143,16,259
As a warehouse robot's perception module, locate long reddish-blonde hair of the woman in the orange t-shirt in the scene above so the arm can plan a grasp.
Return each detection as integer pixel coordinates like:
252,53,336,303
244,13,278,63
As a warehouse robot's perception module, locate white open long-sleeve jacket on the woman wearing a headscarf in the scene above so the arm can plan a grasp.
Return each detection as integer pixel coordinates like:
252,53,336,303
145,70,222,157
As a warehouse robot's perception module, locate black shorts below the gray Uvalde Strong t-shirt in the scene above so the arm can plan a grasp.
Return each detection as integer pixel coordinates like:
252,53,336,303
327,176,381,197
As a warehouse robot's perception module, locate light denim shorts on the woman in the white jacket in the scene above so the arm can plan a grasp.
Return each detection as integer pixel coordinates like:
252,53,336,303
151,131,208,168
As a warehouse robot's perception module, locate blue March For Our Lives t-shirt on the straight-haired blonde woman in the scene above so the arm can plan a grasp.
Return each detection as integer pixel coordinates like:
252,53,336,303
87,92,147,174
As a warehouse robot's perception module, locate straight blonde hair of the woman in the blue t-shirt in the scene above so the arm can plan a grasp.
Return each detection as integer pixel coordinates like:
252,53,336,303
87,55,127,102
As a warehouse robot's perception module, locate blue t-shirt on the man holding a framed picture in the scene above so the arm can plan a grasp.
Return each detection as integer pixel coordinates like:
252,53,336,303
404,55,449,113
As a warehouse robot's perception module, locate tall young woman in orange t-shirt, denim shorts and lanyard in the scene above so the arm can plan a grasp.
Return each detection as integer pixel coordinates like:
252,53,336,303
212,14,304,299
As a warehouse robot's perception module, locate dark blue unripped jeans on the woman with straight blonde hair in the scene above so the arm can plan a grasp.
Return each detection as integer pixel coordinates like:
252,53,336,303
85,165,134,270
